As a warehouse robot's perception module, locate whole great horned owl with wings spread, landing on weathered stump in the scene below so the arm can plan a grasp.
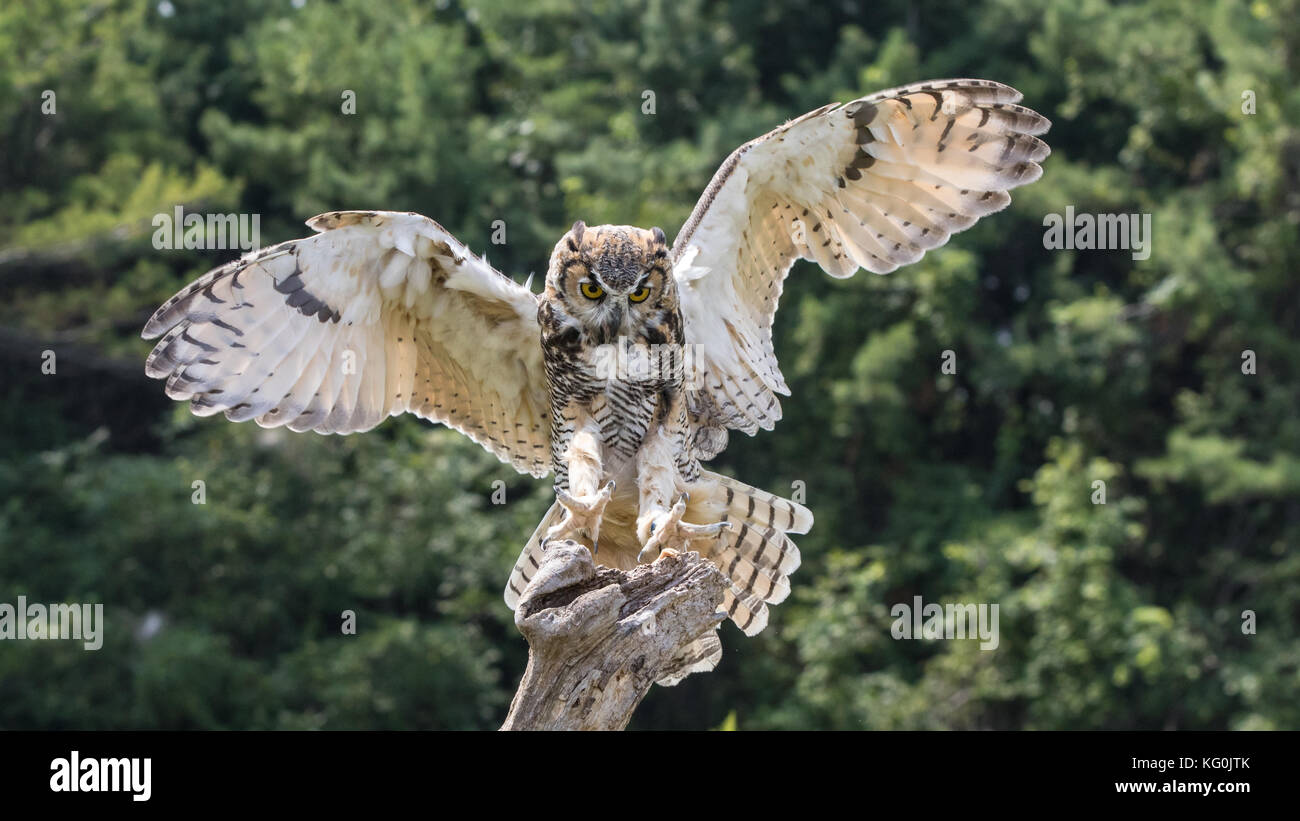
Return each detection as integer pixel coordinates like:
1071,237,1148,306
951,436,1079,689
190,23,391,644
143,79,1049,670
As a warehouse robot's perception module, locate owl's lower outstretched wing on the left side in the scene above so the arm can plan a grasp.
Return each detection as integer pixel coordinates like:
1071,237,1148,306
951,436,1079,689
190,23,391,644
143,212,550,477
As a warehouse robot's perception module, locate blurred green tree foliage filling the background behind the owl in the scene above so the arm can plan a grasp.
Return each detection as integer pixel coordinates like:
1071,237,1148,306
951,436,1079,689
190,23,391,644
0,0,1300,730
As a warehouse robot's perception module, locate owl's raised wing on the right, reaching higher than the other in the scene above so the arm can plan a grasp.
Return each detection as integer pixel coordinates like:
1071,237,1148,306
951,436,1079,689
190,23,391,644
672,79,1050,434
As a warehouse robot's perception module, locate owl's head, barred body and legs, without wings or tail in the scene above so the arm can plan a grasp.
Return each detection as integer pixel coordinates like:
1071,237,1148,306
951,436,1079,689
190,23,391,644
533,222,728,558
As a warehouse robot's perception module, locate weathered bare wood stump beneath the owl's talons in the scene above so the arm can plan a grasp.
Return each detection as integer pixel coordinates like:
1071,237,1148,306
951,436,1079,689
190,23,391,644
501,542,727,730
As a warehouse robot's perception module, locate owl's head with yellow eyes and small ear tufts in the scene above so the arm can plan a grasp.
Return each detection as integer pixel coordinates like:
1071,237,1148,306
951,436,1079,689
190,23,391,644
546,221,677,344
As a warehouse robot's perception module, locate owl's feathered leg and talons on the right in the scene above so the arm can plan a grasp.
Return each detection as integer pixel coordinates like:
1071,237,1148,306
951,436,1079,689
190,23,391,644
637,427,731,561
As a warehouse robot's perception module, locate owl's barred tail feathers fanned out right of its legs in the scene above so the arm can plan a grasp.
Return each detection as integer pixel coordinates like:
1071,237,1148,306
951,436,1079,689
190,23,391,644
683,470,813,635
